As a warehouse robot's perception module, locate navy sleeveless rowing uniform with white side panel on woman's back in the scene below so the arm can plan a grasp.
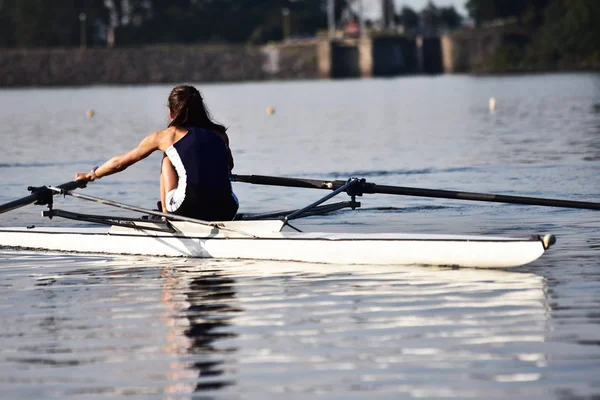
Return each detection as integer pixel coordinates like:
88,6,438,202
166,126,238,221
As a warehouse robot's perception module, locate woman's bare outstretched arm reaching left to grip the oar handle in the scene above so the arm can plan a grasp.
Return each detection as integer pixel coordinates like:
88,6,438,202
75,131,162,182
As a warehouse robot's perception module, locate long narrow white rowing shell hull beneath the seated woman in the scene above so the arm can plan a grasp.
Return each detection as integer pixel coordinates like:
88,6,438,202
0,220,554,268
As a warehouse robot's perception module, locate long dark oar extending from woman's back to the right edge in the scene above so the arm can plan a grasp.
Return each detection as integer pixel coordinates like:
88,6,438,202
231,175,600,210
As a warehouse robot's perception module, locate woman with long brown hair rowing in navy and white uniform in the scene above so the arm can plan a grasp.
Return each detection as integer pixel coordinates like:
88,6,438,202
75,86,238,221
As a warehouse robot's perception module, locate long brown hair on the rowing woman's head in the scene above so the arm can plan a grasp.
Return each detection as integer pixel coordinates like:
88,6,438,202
168,85,227,133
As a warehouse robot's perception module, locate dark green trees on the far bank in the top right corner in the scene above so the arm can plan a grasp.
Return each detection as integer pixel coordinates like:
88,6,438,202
466,0,600,70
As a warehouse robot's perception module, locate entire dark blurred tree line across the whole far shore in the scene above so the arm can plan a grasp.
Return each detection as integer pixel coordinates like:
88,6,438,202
0,0,600,70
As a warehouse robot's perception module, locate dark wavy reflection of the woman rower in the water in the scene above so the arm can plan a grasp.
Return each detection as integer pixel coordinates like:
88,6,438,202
161,265,243,394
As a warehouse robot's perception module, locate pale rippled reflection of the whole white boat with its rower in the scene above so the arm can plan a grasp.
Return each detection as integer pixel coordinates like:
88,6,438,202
0,251,553,399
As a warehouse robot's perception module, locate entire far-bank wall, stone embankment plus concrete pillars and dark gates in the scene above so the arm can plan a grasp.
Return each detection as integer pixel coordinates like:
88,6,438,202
0,29,515,87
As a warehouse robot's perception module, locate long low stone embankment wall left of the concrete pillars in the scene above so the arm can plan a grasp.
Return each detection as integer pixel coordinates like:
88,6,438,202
0,44,318,87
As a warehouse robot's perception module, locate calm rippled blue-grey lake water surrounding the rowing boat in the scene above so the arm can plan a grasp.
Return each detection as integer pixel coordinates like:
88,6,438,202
0,74,600,399
